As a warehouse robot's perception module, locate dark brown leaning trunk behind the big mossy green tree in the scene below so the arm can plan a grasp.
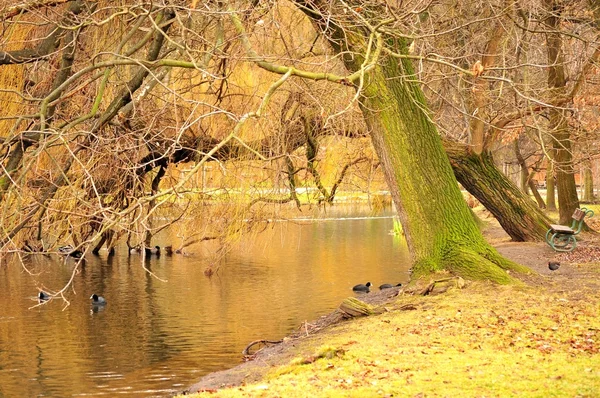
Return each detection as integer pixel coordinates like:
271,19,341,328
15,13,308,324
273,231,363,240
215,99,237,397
444,142,550,242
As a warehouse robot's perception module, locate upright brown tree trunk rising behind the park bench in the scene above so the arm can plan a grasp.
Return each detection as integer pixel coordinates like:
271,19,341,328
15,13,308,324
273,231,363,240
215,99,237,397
545,0,579,224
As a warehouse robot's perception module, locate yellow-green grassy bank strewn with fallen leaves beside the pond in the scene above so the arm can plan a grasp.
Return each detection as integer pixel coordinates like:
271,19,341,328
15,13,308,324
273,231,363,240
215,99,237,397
183,276,600,397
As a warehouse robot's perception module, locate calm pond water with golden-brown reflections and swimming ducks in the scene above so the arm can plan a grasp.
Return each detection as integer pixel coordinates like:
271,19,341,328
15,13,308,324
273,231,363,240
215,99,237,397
0,210,409,397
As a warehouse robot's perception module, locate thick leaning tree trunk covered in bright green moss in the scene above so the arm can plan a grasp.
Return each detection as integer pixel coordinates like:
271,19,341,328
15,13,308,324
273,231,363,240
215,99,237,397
296,1,526,283
